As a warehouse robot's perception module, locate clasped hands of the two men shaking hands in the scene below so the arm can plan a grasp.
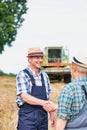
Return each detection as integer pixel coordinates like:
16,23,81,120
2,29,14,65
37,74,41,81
43,101,58,112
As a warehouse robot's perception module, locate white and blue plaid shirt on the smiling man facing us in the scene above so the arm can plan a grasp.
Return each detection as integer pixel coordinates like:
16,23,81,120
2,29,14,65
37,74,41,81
16,67,51,106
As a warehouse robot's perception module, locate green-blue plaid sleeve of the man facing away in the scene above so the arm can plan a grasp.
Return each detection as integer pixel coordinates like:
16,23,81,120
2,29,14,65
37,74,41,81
57,88,72,120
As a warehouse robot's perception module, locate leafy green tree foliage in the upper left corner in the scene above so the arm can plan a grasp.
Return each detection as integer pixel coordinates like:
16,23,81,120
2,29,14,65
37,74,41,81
0,0,28,53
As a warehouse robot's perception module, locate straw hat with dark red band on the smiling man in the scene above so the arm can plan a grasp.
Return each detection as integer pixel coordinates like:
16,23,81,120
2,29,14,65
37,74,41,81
27,48,43,57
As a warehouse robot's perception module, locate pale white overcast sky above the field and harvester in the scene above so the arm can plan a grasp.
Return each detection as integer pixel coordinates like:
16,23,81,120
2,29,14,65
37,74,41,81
0,0,87,74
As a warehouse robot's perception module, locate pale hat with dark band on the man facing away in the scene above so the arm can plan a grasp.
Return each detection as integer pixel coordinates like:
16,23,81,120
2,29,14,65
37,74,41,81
72,50,87,68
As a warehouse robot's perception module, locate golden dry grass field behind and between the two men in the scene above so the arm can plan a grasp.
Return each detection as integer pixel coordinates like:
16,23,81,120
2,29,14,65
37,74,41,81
0,76,64,130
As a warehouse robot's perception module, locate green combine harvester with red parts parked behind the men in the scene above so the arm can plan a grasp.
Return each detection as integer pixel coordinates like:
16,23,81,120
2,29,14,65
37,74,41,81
42,46,71,83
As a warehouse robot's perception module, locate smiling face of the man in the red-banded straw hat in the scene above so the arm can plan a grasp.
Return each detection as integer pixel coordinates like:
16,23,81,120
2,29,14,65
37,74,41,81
29,56,43,69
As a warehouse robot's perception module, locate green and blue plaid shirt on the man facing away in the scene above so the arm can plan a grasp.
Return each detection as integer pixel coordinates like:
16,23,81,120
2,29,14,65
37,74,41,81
57,76,87,121
